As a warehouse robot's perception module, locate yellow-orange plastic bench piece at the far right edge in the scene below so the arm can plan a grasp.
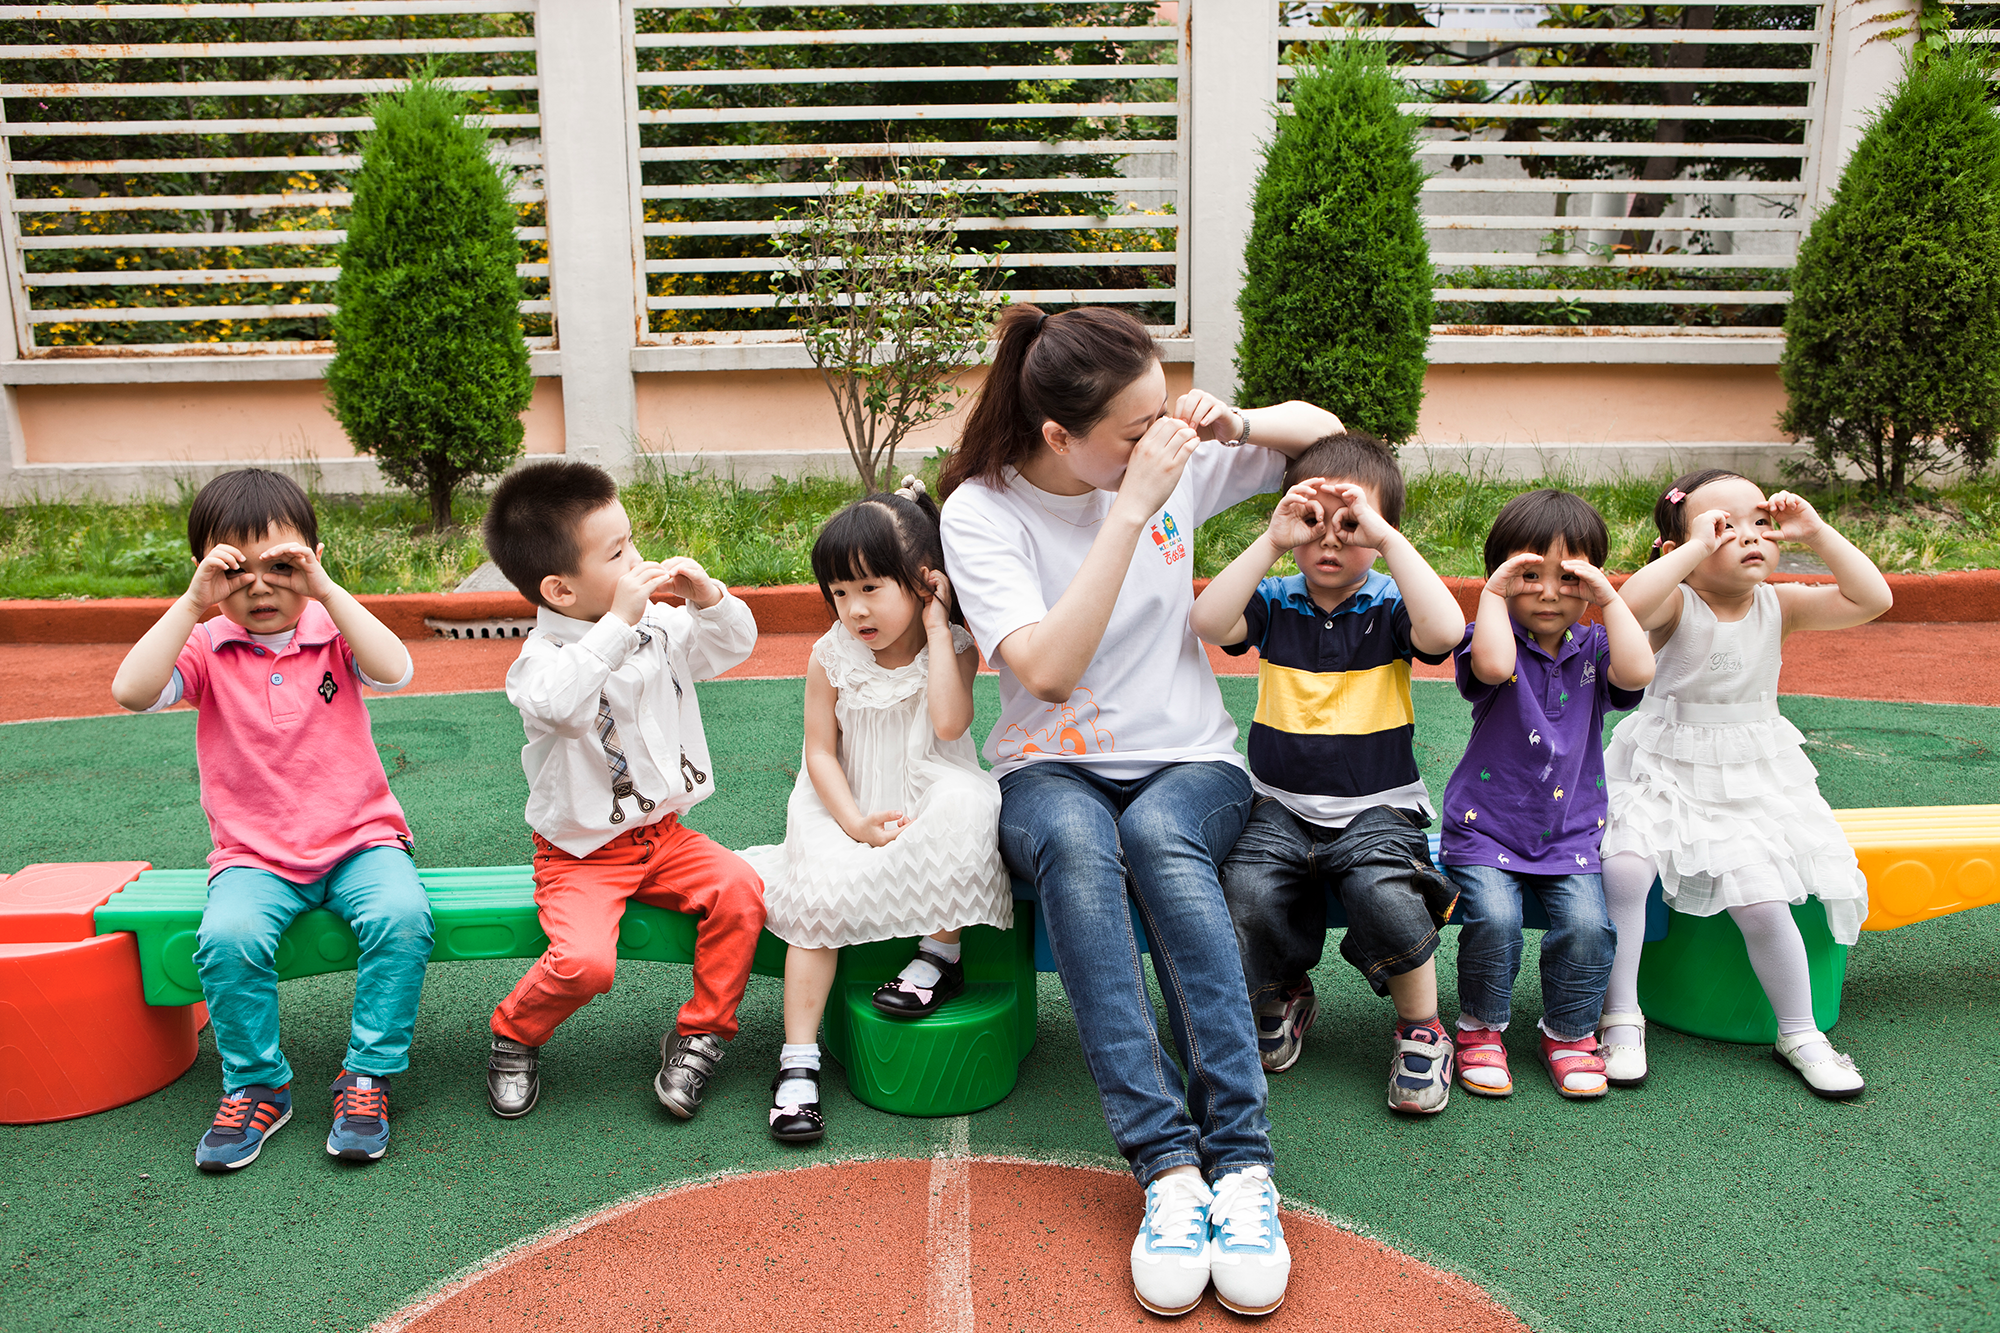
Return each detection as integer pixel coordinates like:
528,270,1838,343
1832,805,2000,931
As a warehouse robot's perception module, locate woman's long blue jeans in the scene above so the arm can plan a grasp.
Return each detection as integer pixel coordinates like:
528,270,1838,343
1000,763,1272,1185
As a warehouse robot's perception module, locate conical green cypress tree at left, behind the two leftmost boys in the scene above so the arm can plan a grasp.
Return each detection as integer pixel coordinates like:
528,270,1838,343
326,74,534,530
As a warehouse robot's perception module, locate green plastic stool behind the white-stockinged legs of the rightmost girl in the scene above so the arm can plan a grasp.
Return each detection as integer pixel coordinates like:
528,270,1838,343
1638,899,1848,1047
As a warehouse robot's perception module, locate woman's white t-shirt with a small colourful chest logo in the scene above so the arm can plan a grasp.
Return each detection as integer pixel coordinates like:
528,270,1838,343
944,442,1284,781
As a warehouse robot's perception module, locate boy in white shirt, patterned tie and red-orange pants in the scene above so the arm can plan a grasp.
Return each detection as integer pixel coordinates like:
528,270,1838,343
486,462,764,1119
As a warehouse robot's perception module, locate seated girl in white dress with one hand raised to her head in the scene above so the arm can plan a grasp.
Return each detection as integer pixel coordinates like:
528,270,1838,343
742,476,1014,1143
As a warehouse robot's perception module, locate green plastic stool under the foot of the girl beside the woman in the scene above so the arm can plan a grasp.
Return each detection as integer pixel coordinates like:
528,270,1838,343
822,903,1036,1115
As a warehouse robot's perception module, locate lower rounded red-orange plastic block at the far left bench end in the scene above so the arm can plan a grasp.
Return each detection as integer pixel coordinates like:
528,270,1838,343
0,931,200,1125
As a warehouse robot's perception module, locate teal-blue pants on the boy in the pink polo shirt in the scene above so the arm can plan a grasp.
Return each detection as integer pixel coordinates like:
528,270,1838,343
194,847,430,1093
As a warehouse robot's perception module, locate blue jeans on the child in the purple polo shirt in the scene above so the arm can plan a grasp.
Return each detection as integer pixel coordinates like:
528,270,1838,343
1446,865,1618,1041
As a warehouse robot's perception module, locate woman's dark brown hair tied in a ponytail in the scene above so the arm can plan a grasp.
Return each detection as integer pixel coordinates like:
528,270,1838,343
938,304,1160,496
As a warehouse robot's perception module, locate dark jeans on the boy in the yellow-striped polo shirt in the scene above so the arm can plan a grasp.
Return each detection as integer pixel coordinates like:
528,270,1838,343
1222,797,1458,1005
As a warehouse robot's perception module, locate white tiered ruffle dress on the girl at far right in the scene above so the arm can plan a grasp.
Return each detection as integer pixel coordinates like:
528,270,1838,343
1602,584,1868,945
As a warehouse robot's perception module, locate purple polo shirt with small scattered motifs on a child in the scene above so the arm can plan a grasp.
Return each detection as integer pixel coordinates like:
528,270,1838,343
1438,620,1646,875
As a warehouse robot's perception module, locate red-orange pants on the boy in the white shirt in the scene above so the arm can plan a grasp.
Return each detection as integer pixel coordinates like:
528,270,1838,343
492,815,764,1047
